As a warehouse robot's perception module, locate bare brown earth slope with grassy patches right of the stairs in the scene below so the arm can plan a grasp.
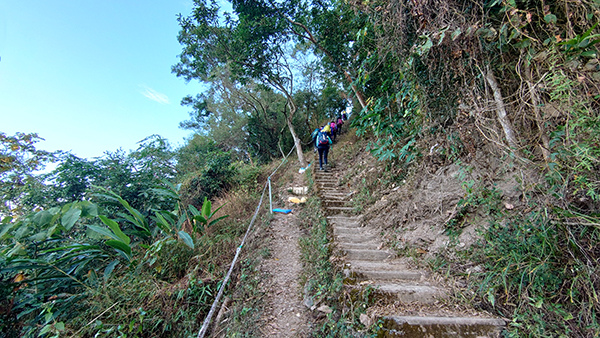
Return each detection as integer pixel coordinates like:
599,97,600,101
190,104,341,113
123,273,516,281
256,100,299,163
316,128,598,336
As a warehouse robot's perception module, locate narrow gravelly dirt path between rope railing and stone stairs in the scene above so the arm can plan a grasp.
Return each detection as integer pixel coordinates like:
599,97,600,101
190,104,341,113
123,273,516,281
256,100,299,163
261,206,310,337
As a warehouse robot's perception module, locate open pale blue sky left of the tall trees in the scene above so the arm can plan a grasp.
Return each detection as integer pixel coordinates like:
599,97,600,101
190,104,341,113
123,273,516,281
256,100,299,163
0,0,201,158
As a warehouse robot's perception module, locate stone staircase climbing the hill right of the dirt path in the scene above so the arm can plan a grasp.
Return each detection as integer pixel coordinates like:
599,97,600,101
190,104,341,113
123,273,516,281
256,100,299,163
314,169,505,337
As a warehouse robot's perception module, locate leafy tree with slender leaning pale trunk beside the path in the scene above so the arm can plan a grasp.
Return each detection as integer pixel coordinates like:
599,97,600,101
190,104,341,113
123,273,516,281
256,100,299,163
173,0,306,166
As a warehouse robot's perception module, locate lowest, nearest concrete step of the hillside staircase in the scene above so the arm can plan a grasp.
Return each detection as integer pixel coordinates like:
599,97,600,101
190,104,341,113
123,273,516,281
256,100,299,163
377,316,506,338
